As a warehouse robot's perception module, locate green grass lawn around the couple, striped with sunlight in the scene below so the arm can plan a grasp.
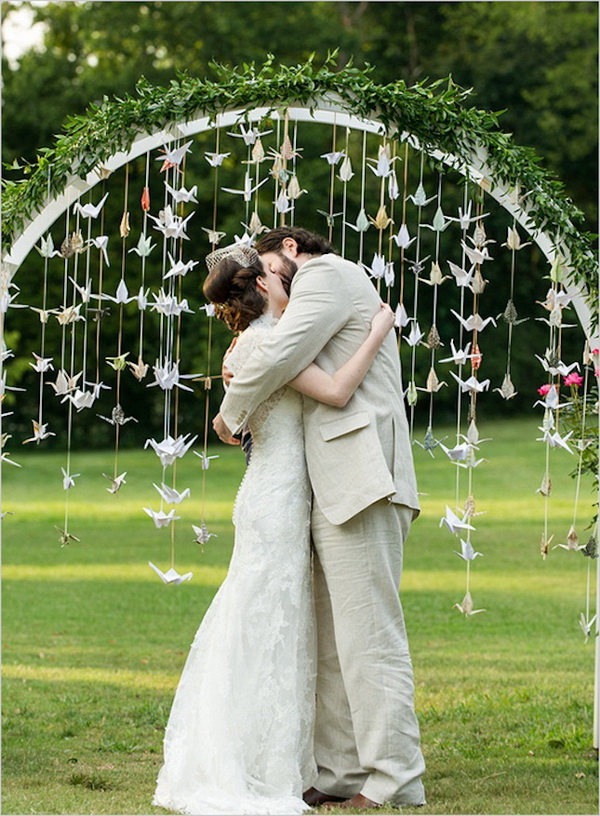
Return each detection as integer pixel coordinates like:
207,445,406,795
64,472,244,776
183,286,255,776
2,419,598,816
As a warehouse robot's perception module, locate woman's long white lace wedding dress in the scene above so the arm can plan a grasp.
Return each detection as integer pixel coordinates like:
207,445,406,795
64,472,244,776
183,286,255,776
153,315,316,816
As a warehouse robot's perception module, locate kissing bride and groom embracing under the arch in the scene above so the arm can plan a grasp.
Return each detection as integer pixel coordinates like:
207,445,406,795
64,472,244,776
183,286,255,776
153,227,425,816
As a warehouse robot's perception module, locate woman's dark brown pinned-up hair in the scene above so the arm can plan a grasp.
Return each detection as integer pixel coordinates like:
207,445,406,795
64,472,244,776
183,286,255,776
202,258,266,332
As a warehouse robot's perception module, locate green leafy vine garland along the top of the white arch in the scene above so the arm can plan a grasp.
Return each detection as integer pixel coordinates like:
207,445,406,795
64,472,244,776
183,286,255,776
2,54,598,314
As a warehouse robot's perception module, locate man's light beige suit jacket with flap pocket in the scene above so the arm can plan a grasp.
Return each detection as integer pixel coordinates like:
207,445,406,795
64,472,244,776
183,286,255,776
221,254,419,524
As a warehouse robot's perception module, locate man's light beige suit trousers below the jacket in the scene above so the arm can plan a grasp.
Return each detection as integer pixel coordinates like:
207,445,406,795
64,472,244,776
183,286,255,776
312,499,425,805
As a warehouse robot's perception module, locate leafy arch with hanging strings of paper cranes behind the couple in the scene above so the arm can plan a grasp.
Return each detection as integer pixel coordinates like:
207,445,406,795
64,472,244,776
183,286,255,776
0,61,600,716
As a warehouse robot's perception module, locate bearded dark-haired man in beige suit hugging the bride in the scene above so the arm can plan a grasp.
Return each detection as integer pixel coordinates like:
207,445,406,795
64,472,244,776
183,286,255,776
213,227,425,810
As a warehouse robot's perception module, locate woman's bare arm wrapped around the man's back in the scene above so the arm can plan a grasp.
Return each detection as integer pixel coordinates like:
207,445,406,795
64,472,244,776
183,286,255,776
288,303,394,408
